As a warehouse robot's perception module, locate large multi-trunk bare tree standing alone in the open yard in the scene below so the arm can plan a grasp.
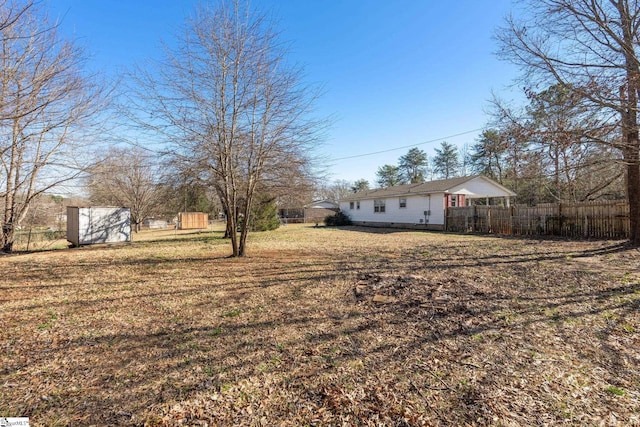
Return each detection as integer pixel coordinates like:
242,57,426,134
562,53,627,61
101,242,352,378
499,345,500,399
127,0,318,256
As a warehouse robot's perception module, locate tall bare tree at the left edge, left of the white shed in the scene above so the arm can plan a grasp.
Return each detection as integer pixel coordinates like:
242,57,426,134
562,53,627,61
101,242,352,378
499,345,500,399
0,0,104,252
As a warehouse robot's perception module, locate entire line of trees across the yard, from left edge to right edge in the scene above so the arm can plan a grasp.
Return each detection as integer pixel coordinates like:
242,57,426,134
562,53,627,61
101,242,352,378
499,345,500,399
0,0,640,251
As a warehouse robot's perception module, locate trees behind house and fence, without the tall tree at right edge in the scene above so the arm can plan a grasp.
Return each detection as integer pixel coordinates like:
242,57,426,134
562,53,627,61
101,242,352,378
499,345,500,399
362,80,626,205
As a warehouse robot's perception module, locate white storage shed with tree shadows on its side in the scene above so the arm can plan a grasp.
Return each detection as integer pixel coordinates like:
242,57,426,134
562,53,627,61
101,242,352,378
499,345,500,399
67,206,131,246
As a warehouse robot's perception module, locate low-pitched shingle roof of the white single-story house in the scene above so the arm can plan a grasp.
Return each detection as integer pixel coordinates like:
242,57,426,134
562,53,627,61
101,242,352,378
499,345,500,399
341,175,516,202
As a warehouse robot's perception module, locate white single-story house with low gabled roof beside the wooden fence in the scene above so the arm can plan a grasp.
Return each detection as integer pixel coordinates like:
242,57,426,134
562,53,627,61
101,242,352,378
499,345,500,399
340,175,516,230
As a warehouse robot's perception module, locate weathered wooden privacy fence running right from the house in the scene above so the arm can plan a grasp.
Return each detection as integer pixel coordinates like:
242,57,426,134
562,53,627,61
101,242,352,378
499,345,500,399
446,200,629,239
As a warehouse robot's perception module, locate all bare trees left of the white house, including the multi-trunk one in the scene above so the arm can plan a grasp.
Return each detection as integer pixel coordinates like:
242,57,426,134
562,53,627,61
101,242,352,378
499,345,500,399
0,0,325,256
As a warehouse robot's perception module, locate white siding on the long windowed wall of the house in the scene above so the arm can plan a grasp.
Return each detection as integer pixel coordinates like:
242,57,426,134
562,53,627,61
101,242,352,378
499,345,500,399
340,193,444,225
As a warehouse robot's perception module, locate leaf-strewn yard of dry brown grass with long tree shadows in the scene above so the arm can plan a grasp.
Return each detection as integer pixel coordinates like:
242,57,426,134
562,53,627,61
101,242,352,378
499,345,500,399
0,225,640,426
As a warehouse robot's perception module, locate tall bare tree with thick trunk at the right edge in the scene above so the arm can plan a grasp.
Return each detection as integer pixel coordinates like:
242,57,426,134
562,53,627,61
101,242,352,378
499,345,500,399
497,0,640,245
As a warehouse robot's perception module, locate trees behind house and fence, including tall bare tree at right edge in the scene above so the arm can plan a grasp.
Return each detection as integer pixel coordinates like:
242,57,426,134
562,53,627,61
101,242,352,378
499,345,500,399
348,0,640,244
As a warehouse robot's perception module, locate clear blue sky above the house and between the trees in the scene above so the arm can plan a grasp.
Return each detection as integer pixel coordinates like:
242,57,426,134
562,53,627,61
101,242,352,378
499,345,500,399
45,0,517,184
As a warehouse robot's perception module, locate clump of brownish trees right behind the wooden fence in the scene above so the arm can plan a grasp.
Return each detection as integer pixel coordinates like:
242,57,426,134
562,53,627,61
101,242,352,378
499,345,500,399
482,86,625,204
